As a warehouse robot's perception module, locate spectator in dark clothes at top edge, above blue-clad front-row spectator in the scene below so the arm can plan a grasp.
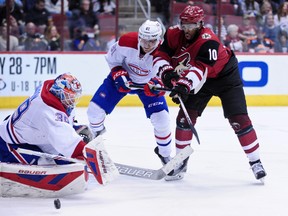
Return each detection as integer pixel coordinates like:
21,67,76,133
69,0,99,38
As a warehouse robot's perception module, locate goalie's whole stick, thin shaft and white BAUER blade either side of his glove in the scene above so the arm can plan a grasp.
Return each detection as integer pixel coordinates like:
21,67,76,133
15,146,193,180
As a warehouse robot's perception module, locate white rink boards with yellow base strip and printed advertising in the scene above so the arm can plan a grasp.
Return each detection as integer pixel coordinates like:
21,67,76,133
0,52,288,108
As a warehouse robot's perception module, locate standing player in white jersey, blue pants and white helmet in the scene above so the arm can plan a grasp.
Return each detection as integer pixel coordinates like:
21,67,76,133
87,20,172,170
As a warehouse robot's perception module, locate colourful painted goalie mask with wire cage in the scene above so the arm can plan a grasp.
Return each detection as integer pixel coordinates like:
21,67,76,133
50,73,82,114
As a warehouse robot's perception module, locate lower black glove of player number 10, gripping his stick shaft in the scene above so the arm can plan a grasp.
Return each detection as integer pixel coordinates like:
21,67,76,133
169,77,193,104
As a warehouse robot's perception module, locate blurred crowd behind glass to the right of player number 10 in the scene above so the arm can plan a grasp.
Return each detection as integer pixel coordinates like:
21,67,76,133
177,0,288,53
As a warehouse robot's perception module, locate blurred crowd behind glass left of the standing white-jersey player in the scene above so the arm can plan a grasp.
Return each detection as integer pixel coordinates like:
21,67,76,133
0,0,116,51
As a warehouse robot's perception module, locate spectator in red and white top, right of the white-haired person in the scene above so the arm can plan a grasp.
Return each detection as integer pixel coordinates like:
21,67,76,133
239,15,257,42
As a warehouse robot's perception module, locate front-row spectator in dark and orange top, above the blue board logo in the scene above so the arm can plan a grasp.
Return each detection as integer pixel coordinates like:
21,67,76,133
247,28,274,53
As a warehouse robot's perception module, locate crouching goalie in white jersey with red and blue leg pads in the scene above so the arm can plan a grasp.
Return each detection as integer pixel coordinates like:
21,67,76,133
0,73,116,197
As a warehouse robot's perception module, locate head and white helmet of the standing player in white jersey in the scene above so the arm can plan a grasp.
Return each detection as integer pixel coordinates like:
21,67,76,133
138,20,162,53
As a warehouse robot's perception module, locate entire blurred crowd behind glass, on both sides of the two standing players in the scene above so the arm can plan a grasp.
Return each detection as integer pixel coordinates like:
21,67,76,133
0,0,288,53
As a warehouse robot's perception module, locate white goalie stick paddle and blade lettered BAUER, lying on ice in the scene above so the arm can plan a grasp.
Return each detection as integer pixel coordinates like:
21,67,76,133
115,146,193,180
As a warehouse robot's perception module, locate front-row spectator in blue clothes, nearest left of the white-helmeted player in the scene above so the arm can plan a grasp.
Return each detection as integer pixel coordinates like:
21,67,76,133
72,27,101,51
